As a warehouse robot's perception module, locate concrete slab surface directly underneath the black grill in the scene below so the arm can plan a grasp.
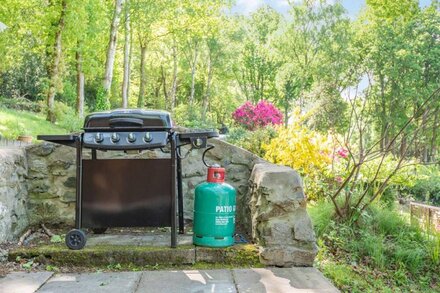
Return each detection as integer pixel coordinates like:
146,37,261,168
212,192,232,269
86,233,192,247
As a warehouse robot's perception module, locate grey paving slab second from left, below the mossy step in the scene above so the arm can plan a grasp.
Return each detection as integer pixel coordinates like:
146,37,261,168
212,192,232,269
37,272,141,293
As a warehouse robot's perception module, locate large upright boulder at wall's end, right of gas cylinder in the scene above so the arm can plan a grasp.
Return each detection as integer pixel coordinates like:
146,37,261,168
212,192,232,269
249,163,317,267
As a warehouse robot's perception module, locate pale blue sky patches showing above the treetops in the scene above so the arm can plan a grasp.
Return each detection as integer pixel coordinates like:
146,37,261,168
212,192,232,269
232,0,431,17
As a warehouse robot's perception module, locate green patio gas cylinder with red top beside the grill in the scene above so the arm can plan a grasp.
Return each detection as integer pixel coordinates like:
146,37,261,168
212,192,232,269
193,165,236,247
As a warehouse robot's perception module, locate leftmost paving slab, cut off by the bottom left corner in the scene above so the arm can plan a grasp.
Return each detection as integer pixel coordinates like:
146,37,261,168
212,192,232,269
0,272,53,293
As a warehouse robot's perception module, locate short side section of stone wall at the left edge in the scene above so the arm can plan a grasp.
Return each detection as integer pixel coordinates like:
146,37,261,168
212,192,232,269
0,149,29,243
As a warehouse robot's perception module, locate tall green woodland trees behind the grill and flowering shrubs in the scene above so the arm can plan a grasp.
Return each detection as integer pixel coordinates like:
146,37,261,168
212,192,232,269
0,0,440,162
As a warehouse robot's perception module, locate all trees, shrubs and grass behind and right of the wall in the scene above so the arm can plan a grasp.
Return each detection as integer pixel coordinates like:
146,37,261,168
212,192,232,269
0,0,440,292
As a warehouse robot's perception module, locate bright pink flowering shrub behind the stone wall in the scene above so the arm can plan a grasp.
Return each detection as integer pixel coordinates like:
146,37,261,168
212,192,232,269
232,100,283,130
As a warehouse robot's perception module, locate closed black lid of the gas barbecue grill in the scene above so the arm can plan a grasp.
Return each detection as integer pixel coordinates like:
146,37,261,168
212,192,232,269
84,109,173,131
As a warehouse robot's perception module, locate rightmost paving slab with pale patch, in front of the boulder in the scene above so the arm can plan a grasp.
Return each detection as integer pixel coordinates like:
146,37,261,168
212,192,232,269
233,268,339,293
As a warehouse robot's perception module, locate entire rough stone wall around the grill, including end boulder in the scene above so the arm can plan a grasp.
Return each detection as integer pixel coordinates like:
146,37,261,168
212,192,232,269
0,139,317,266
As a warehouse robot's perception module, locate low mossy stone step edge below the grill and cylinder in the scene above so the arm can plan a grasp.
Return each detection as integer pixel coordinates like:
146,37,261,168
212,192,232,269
9,244,260,267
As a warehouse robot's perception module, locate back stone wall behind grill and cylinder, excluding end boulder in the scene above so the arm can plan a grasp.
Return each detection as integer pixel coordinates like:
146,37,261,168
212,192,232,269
27,139,261,231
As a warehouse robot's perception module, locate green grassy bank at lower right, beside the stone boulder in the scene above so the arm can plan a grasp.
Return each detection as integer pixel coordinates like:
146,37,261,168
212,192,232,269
309,202,440,292
